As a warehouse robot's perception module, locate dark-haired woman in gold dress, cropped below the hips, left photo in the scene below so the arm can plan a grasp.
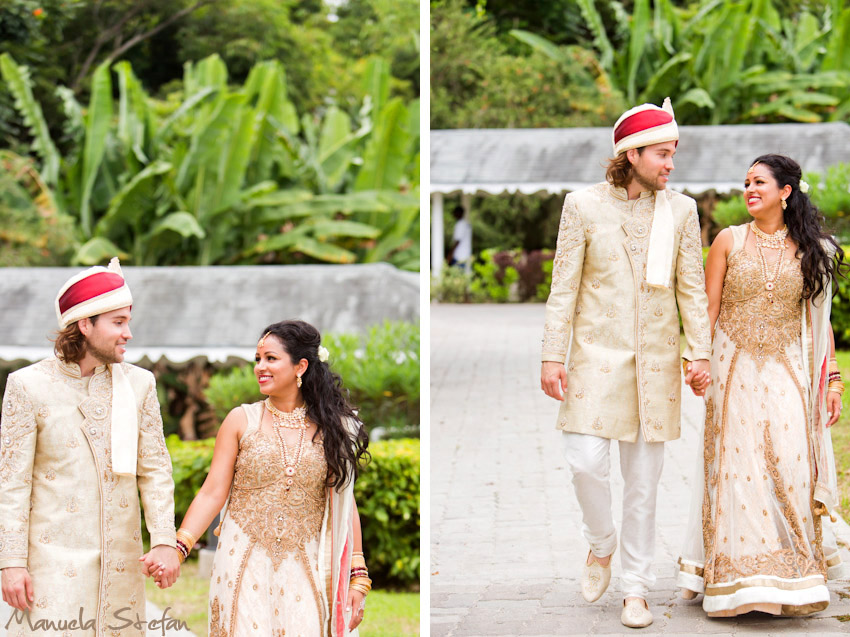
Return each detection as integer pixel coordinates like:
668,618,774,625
151,321,371,637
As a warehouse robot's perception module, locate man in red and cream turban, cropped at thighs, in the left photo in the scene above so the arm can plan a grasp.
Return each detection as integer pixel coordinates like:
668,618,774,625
0,259,180,637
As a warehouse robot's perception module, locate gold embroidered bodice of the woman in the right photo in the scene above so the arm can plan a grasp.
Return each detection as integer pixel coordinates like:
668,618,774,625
718,249,803,368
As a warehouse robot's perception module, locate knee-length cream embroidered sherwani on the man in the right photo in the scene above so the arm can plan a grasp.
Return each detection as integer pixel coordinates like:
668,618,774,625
542,183,711,442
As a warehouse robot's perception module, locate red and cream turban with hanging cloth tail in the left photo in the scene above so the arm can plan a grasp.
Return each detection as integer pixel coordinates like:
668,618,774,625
56,257,139,475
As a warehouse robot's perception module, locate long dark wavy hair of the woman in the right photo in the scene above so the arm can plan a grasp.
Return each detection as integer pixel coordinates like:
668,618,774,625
750,155,850,299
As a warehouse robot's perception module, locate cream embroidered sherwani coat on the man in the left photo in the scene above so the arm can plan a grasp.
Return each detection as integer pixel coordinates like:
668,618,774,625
0,358,175,637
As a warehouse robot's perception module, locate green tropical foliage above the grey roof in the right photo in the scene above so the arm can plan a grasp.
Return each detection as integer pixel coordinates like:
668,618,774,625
431,0,850,128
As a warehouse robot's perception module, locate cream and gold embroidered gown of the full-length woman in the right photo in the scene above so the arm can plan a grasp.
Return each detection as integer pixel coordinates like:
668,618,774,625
678,250,829,616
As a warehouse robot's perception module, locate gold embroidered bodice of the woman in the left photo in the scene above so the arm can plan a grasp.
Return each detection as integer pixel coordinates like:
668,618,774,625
227,420,328,569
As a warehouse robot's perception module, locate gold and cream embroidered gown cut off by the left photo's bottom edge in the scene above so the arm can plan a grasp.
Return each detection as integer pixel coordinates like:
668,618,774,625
209,403,329,637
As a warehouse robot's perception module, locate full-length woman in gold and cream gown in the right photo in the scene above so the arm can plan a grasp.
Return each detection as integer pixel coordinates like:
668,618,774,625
678,155,848,617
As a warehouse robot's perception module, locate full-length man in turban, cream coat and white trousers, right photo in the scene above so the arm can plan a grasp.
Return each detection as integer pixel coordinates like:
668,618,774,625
540,98,711,628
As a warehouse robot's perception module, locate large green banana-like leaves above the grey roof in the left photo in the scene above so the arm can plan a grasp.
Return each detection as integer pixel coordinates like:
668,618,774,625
0,54,419,269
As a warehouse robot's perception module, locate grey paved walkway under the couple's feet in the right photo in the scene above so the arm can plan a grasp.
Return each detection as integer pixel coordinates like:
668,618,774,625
430,305,850,637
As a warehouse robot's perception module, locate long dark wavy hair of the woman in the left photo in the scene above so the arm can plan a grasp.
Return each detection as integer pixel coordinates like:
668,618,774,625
261,321,369,489
